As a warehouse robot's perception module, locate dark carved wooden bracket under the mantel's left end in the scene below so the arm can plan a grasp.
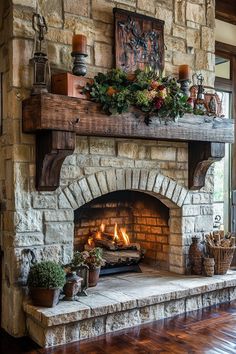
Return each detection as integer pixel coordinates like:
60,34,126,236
36,130,76,191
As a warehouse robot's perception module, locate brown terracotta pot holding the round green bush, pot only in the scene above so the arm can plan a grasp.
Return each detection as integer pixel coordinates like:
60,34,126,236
30,288,61,307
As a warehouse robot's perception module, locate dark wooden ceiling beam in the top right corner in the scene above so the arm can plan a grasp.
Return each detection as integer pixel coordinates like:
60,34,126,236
216,0,236,25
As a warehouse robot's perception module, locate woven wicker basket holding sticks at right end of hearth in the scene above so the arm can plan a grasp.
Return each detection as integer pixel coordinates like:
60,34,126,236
208,245,235,274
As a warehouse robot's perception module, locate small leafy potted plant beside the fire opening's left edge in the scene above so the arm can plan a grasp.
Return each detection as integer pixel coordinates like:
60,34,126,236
71,247,105,287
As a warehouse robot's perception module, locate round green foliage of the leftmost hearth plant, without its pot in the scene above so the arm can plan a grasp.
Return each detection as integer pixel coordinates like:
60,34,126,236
28,261,65,289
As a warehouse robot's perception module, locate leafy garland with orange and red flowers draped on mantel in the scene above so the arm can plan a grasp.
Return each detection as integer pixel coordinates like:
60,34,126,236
84,69,192,124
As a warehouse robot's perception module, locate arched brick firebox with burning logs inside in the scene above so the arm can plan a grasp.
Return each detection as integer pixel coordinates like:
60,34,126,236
74,191,169,273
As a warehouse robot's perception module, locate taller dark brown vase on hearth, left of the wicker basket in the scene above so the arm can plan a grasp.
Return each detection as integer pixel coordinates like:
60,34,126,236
188,236,203,275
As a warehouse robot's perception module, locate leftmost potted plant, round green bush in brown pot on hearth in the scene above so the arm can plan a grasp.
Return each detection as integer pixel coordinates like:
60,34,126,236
28,261,65,307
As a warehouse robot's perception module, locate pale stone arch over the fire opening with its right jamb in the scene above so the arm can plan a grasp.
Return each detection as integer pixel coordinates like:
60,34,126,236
59,168,188,274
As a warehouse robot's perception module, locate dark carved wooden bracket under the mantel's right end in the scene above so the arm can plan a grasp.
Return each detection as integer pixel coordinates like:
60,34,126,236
188,141,225,190
